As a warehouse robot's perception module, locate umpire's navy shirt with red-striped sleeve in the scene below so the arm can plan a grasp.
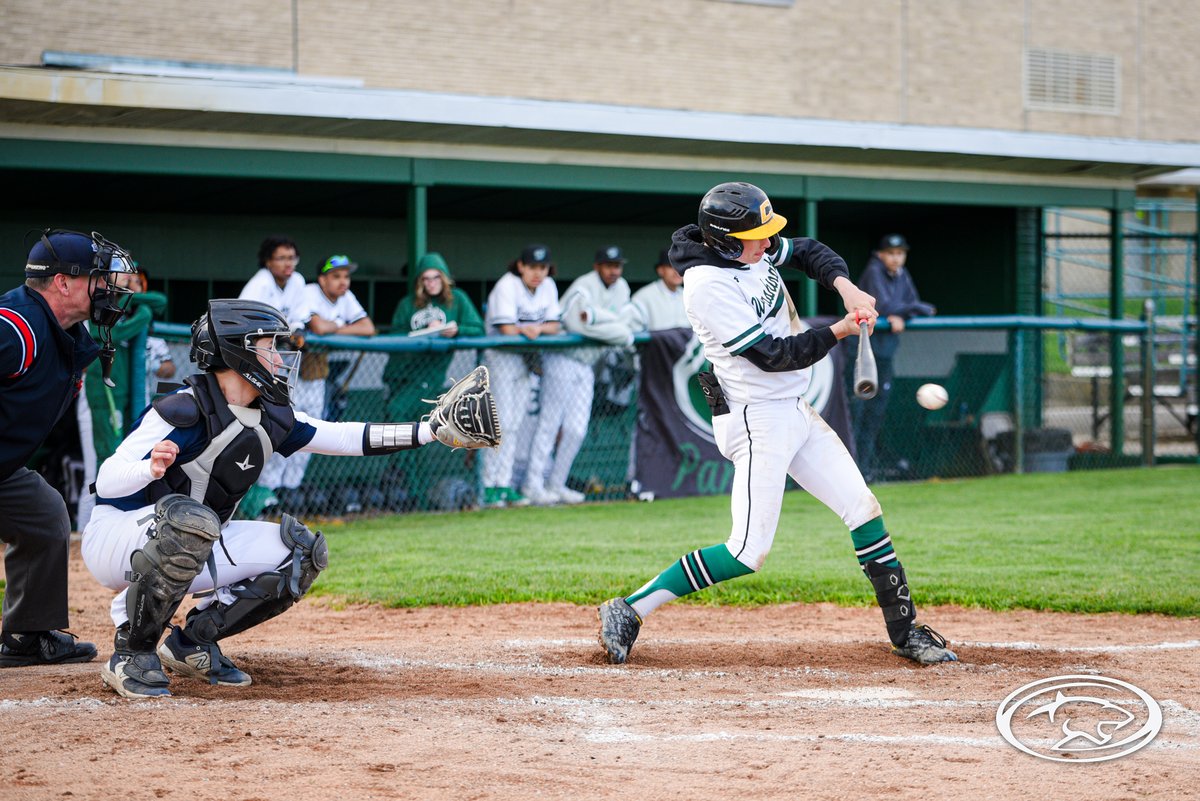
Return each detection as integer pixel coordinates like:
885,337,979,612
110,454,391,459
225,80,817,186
0,285,100,481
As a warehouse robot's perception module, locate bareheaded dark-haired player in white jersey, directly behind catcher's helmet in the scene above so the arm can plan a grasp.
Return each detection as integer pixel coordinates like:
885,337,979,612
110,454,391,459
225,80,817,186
238,235,312,510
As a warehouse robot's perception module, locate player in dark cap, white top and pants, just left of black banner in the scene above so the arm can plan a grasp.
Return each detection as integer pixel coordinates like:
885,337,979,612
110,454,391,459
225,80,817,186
521,245,636,506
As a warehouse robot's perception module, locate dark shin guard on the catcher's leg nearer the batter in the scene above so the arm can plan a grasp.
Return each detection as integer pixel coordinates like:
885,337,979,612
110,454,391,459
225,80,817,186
184,514,329,647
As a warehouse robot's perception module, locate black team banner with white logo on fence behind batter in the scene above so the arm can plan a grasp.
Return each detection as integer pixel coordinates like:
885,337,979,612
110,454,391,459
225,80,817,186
636,317,854,498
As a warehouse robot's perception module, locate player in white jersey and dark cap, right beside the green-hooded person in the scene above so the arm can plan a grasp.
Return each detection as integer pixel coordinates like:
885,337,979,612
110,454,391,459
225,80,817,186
484,245,562,506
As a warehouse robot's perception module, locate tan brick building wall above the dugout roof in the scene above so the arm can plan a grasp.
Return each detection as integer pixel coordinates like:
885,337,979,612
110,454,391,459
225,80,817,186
0,0,1200,141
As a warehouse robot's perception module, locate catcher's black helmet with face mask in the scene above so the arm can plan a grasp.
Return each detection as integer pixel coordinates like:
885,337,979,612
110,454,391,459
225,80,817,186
191,300,300,404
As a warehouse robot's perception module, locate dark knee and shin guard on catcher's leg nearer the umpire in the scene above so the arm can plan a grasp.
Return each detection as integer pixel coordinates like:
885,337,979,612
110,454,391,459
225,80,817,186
125,495,221,651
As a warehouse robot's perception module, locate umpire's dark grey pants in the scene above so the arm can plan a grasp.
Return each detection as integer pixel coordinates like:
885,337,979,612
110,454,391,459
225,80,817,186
0,468,71,632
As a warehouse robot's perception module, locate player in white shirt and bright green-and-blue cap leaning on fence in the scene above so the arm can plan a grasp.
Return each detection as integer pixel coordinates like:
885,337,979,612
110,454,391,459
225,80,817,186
296,255,376,422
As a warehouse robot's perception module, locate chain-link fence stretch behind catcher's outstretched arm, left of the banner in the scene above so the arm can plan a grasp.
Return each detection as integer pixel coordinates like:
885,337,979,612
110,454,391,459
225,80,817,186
148,325,638,517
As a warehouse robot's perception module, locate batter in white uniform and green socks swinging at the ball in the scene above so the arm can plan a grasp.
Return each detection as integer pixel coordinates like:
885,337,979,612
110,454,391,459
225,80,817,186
599,182,958,664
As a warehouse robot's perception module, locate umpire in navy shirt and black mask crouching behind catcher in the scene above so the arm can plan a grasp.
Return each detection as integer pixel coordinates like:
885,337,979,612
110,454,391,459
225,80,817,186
0,229,132,668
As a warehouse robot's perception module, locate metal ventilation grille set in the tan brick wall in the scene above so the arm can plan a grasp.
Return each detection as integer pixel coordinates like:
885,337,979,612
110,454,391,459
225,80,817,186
1025,48,1121,114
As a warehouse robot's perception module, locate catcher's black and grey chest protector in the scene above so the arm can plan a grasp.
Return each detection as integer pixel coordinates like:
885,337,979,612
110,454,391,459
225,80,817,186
146,373,295,523
